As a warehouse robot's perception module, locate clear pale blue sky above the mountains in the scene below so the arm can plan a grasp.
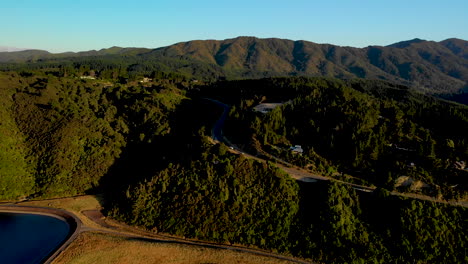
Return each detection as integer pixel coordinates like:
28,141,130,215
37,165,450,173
0,0,468,52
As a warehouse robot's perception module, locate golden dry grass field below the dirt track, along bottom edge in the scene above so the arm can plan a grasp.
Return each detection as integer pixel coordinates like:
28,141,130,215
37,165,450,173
52,233,290,264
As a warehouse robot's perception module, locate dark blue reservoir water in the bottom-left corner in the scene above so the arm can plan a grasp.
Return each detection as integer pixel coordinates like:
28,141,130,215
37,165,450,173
0,212,70,263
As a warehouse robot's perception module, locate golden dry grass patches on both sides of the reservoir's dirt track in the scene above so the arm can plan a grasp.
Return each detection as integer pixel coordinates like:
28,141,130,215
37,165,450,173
19,195,300,264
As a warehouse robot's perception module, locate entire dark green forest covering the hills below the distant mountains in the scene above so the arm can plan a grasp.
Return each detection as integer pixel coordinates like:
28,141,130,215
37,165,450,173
0,59,468,263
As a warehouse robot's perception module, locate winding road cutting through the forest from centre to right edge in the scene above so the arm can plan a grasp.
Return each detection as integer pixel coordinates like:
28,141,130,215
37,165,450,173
205,98,468,207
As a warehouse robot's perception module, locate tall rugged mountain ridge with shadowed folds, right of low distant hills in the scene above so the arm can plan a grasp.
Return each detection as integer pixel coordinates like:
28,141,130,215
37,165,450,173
151,37,468,91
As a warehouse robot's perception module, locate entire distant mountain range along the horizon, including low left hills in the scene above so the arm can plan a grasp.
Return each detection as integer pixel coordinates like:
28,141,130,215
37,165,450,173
0,37,468,94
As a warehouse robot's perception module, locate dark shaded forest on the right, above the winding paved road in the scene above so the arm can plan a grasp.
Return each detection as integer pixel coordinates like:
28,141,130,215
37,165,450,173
205,78,468,199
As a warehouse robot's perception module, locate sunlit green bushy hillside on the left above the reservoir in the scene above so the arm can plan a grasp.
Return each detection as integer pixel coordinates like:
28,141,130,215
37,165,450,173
0,70,184,199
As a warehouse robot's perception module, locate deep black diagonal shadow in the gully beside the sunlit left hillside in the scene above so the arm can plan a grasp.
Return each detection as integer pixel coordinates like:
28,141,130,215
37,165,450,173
89,99,223,212
